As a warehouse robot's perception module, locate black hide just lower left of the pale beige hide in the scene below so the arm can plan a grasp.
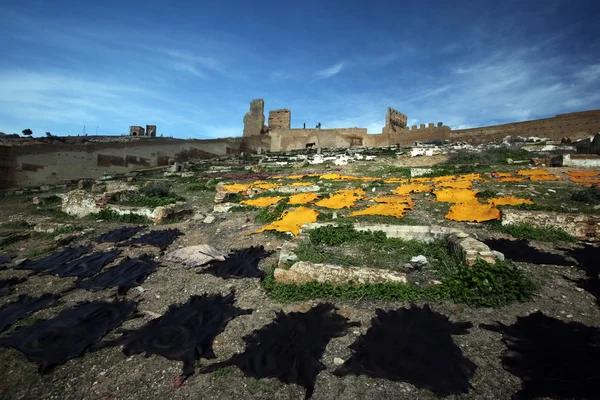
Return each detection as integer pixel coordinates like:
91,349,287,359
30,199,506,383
77,254,158,294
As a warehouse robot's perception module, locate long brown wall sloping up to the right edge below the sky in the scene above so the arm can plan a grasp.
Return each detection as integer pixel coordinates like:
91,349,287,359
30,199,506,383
450,110,600,144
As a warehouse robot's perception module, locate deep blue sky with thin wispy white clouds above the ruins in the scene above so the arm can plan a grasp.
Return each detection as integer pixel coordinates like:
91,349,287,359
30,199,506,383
0,0,600,138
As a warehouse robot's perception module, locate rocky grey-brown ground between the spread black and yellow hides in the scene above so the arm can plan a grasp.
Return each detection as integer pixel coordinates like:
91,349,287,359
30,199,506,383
0,145,600,399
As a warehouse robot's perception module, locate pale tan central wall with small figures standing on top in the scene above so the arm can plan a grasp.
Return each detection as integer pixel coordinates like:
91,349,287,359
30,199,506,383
269,128,369,151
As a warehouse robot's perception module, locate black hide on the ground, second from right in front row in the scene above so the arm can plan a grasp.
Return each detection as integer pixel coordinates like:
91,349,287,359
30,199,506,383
334,305,477,396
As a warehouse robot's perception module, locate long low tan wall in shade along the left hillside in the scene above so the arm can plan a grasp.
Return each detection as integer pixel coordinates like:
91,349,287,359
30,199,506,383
0,138,244,189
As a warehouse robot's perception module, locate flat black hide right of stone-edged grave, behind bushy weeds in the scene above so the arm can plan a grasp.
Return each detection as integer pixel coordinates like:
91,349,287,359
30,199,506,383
483,239,573,265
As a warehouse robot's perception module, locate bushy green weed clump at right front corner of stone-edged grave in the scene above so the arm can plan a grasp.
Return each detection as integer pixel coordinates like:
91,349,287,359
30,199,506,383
444,259,535,307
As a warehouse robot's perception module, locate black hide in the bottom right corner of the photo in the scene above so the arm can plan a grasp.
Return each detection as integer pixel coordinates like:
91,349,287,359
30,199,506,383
481,311,600,400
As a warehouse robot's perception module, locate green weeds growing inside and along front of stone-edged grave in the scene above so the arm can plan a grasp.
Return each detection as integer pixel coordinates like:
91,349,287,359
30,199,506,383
263,226,535,307
